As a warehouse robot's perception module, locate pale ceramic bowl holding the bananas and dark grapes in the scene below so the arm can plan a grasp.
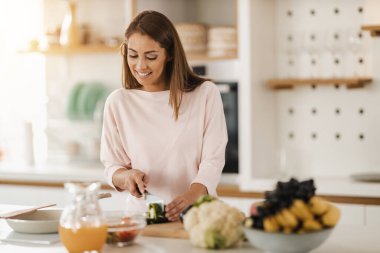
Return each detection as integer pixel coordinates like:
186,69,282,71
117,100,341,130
243,227,333,253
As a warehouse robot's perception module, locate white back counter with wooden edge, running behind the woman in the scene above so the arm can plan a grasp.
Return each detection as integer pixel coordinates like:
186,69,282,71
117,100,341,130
0,163,380,205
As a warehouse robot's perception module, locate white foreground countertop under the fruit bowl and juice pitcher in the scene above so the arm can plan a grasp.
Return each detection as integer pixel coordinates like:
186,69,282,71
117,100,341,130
0,205,380,253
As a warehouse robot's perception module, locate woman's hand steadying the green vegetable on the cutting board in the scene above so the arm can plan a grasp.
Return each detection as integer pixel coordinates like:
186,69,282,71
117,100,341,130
166,183,207,221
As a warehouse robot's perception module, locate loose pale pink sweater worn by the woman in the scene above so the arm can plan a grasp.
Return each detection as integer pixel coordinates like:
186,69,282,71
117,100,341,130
100,81,227,202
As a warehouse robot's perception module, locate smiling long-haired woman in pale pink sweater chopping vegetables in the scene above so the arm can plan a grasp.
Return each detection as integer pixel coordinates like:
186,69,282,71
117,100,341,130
101,11,227,221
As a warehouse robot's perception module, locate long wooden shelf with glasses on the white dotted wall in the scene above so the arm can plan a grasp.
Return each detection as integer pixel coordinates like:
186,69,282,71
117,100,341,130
267,77,372,89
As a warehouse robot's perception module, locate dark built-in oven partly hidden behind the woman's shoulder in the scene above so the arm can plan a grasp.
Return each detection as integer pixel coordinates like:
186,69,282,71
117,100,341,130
215,81,239,174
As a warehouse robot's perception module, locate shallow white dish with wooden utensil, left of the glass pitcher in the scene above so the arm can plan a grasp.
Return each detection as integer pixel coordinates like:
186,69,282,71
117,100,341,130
6,209,62,234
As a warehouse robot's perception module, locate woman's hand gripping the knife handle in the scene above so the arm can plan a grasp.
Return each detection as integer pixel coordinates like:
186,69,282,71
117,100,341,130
112,168,148,198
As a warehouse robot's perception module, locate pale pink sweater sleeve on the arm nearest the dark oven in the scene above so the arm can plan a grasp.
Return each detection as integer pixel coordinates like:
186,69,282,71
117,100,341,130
192,84,228,196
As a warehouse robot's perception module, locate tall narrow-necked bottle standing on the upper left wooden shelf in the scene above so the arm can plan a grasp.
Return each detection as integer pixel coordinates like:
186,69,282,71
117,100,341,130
59,0,80,47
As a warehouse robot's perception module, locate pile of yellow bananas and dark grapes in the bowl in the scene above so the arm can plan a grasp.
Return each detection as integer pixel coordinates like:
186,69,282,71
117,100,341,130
244,179,340,233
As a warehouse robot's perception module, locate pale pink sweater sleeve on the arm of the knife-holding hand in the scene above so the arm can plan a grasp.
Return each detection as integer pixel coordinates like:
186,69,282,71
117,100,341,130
100,94,131,190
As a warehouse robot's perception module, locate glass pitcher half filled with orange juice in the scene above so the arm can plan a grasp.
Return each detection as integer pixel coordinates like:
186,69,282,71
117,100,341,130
59,182,107,253
